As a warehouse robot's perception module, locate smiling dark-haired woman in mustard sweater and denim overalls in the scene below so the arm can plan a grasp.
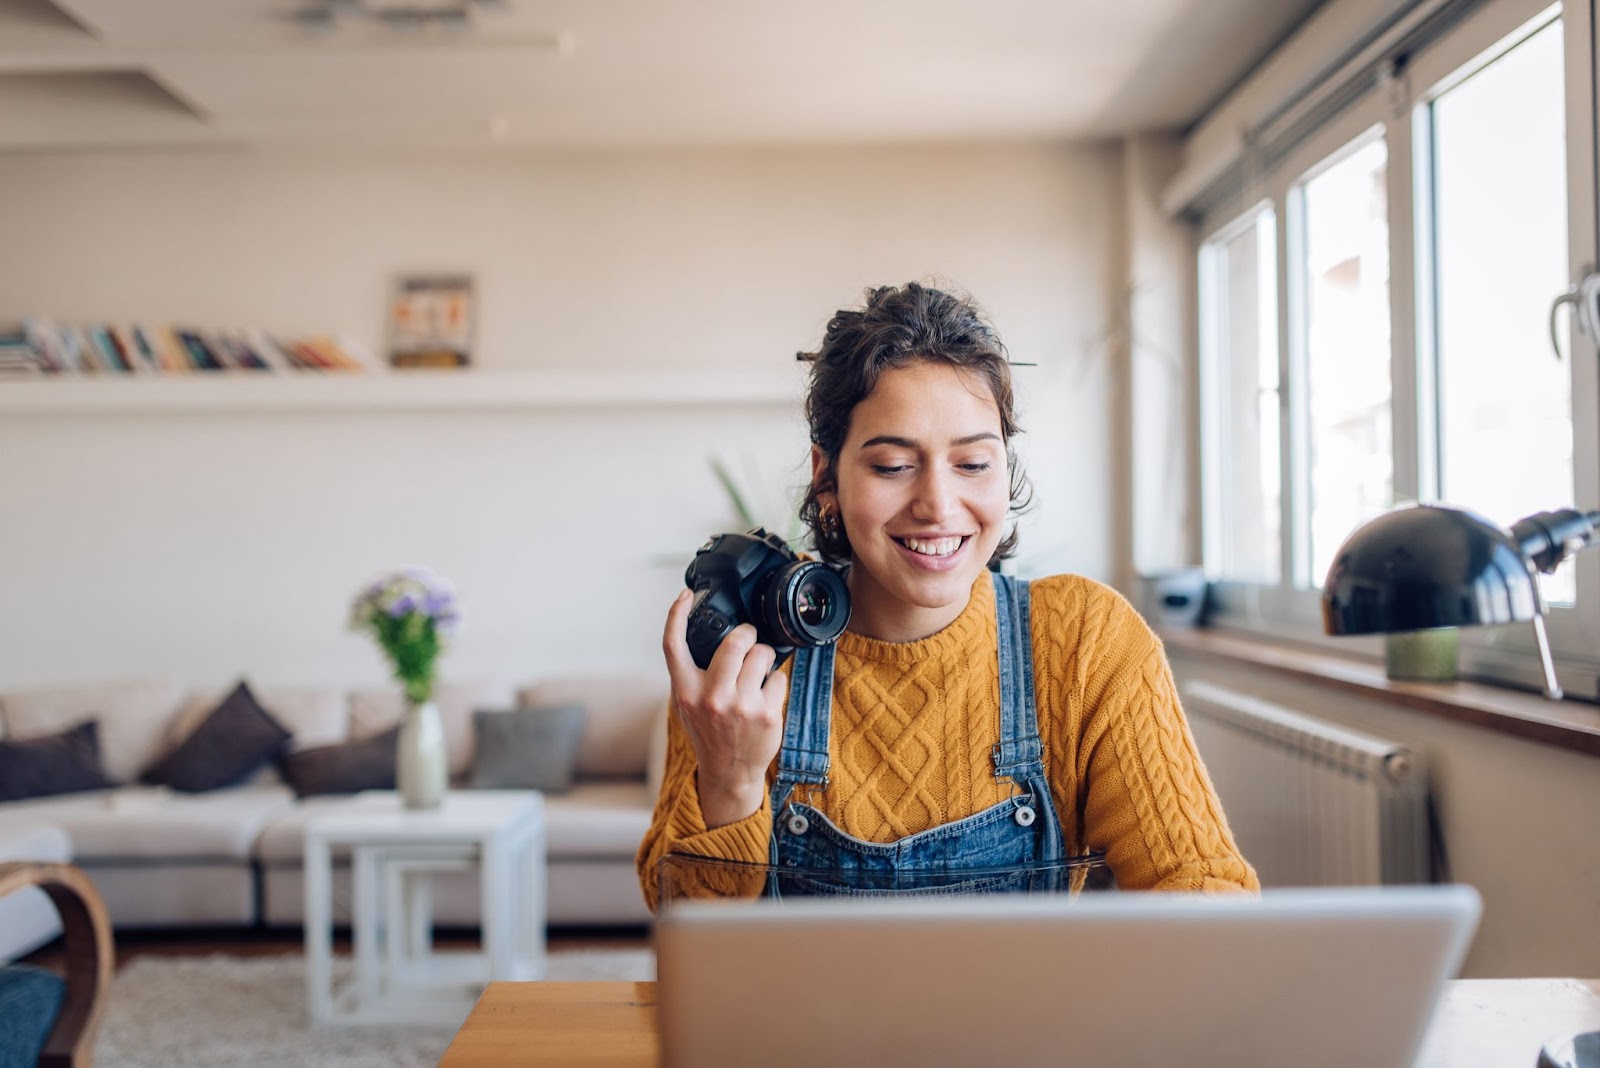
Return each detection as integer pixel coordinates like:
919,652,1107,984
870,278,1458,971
638,283,1258,907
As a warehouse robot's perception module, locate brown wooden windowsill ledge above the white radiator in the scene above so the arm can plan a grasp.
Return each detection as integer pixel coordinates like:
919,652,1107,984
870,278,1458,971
1160,630,1600,756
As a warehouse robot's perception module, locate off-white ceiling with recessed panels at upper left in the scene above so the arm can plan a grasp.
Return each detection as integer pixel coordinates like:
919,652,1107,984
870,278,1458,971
0,0,1318,152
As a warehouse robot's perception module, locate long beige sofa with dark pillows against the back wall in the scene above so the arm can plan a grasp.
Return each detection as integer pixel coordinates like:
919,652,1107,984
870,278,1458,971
0,676,666,956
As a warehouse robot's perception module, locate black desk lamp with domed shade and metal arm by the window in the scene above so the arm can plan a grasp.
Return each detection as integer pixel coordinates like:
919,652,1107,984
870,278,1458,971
1322,504,1600,1068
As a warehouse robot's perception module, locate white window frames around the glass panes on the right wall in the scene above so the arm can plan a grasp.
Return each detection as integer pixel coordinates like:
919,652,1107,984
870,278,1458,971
1195,0,1600,697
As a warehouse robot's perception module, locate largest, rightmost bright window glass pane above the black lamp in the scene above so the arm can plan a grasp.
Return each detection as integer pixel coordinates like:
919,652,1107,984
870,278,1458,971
1430,21,1576,603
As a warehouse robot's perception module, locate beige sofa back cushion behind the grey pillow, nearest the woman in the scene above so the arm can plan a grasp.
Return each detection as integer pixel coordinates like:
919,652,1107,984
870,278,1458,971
518,675,667,779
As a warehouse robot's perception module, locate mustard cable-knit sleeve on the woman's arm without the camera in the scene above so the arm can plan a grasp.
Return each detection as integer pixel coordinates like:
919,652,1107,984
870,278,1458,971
1053,580,1261,892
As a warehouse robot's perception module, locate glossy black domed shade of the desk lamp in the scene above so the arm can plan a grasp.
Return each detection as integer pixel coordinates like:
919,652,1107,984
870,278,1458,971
1322,504,1539,635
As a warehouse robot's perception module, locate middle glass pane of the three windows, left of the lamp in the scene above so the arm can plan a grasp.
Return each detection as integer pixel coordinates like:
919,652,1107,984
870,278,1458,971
1298,141,1394,587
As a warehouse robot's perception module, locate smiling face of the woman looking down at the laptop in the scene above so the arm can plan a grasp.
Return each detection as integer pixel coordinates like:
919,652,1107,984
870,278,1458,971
811,361,1011,641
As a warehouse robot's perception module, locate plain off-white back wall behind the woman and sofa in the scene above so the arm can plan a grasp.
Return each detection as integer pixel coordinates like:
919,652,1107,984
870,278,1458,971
0,145,1118,687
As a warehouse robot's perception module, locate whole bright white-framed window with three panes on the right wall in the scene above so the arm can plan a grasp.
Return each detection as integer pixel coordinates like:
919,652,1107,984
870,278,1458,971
1197,0,1600,692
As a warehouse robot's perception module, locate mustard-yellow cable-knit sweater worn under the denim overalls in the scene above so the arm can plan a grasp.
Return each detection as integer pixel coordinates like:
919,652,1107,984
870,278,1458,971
638,571,1259,908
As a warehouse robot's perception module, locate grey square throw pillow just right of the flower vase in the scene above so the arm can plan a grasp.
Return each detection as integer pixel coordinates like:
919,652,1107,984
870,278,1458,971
469,705,584,793
